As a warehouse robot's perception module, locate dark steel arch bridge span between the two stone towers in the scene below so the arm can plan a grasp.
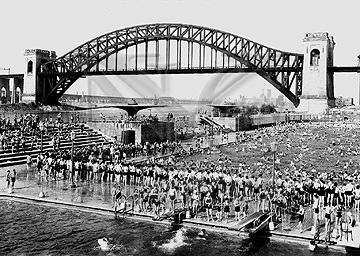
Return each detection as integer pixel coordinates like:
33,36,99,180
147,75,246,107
37,24,304,106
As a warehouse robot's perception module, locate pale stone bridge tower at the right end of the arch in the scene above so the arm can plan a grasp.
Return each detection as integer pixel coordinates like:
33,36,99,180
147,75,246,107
297,32,335,114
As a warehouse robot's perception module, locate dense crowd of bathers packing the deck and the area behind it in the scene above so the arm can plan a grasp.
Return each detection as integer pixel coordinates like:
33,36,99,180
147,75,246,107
4,112,360,240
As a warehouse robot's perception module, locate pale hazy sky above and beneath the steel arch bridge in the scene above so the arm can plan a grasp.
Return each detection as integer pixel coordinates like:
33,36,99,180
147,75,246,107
0,0,360,102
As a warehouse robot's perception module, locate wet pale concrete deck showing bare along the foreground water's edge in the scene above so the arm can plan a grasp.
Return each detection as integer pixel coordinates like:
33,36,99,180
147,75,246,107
0,170,354,254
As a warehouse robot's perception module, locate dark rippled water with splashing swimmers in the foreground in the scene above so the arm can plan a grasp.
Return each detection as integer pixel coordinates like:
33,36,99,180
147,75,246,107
0,200,344,256
